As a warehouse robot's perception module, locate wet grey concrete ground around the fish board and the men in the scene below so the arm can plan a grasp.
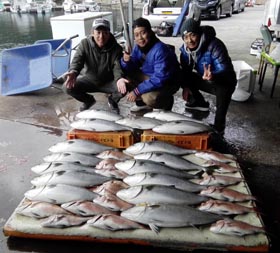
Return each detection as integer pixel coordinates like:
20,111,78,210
0,6,280,253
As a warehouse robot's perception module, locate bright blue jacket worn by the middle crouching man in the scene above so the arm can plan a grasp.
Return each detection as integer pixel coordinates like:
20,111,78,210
121,41,180,95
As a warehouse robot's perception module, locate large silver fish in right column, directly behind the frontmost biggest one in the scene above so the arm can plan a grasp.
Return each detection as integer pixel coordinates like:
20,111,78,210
116,185,208,205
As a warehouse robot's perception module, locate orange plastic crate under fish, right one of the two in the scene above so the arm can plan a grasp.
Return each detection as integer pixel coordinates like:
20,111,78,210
141,130,210,150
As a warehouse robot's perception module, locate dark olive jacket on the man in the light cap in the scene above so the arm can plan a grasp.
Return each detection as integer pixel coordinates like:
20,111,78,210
69,34,123,85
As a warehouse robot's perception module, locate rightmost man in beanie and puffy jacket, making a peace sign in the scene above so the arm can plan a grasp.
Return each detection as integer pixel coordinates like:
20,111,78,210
180,18,237,135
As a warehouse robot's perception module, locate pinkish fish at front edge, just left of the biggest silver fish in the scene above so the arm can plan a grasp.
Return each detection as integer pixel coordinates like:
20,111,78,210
87,214,145,231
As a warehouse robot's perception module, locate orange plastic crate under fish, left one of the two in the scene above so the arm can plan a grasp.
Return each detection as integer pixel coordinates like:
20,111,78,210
67,129,134,149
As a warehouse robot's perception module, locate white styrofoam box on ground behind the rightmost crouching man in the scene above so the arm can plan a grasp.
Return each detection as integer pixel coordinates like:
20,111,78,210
232,61,257,102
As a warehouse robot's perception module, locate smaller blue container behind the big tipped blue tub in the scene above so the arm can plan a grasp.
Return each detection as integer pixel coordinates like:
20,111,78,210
35,39,72,79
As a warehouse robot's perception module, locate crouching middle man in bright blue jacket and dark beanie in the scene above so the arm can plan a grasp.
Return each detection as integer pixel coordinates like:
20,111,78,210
117,18,180,112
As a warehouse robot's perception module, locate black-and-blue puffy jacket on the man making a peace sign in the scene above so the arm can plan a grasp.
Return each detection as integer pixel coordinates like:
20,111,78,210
180,26,237,85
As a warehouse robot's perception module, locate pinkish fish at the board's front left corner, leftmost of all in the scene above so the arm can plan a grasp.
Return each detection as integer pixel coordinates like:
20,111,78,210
15,201,69,219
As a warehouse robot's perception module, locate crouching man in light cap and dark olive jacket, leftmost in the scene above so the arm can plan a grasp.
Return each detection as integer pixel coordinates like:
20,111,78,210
63,18,123,113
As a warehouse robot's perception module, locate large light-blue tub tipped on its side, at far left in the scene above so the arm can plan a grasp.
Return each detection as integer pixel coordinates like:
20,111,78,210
0,43,52,96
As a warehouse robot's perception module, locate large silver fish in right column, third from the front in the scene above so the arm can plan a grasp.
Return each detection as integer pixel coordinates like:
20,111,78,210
123,172,205,192
